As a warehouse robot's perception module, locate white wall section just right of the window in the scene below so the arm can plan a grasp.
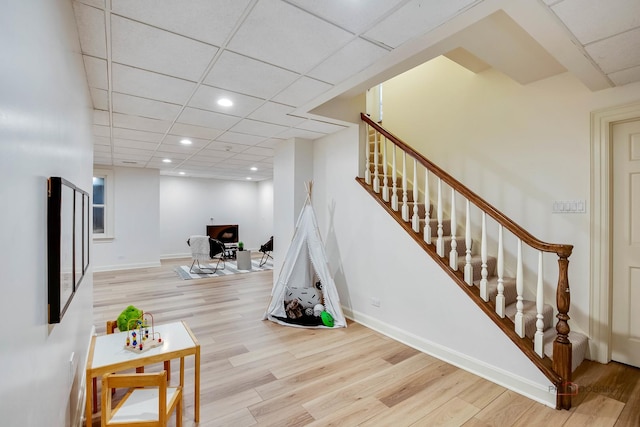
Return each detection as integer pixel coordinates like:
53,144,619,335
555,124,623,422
93,167,160,271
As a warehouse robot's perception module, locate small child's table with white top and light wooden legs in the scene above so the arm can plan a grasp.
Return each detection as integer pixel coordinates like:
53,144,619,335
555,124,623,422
85,322,200,426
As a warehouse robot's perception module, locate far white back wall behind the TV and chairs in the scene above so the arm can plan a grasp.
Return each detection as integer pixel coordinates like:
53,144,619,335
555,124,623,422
158,176,273,258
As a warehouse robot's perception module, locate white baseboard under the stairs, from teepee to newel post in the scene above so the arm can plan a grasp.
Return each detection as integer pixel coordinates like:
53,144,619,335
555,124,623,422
342,307,556,409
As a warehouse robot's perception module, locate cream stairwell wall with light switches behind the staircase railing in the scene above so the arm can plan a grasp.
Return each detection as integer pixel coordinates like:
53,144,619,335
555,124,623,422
383,57,640,333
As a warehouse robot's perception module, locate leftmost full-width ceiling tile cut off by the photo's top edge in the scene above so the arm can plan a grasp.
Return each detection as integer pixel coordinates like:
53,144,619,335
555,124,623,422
111,0,249,46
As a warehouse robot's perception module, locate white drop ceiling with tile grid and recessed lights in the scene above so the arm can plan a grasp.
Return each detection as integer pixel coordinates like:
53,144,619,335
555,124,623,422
73,0,640,181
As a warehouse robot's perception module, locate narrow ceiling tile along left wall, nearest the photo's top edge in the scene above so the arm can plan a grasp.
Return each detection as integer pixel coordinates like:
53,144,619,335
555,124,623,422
73,3,107,58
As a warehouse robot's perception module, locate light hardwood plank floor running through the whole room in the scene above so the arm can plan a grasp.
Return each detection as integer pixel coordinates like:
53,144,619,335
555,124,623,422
93,259,640,427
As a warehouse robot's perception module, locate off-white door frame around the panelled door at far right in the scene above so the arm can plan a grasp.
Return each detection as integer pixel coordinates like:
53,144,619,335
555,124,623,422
589,102,640,363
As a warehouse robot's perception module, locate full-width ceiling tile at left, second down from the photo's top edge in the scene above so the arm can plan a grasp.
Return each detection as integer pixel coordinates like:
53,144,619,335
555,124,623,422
111,16,218,81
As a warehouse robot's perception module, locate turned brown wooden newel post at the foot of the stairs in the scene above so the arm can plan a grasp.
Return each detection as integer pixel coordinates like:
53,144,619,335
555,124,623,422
553,251,577,409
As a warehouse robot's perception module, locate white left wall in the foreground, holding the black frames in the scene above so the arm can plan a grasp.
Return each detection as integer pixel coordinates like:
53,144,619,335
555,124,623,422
0,0,93,427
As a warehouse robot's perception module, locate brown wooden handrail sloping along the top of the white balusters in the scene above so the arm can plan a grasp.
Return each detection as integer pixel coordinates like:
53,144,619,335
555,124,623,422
360,113,573,258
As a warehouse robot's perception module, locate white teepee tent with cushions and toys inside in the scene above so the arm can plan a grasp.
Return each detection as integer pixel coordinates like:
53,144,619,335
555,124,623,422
263,183,347,328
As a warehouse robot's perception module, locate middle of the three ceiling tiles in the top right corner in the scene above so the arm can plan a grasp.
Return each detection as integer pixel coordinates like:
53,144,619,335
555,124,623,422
585,28,640,74
